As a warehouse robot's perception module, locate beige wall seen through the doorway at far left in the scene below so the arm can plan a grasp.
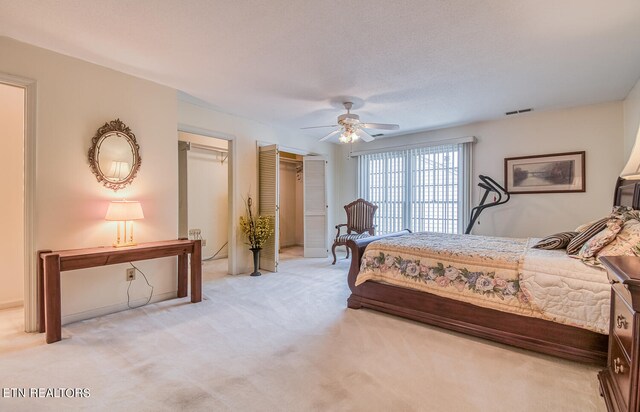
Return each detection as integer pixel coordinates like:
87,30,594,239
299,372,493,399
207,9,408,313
0,83,24,309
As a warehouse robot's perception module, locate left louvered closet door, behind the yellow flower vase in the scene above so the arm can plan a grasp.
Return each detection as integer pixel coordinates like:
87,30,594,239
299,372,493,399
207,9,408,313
258,145,280,272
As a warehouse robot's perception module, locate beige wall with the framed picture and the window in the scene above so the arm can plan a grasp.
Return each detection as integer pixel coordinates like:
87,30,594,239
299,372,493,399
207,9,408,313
336,102,624,237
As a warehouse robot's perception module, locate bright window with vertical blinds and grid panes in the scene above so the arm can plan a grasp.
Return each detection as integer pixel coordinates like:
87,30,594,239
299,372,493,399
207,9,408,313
358,142,471,234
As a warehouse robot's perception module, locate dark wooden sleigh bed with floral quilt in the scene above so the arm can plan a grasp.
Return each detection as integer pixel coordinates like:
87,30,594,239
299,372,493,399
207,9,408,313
347,180,640,365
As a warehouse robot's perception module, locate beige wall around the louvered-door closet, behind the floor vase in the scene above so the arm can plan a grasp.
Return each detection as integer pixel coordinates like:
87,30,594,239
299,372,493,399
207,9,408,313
178,97,335,274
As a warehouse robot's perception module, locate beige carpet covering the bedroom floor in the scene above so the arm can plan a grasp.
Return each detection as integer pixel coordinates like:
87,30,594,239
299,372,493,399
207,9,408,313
0,248,605,412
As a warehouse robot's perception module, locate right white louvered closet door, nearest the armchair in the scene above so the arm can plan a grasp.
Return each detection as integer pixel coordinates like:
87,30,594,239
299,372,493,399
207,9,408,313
303,156,329,257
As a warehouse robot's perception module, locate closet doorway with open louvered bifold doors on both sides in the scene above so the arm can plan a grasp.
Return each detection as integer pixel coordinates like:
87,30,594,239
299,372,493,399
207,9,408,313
258,145,328,272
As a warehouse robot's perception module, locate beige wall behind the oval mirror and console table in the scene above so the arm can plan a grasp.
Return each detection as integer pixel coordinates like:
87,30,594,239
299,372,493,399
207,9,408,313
0,37,178,322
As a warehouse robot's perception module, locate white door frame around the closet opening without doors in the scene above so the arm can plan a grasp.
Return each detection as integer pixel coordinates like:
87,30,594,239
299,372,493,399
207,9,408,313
178,123,240,275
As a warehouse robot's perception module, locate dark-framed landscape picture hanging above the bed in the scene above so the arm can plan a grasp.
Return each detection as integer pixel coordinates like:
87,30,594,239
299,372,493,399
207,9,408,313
504,152,585,194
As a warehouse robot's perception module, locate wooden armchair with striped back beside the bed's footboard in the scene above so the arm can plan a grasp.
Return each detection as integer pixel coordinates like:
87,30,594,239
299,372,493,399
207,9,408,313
331,199,378,265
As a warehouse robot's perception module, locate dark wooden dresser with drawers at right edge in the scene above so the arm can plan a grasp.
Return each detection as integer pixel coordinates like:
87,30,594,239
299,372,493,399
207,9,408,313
598,256,640,412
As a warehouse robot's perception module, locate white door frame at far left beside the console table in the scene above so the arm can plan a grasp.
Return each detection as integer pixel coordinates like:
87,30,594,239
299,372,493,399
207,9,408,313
0,73,39,332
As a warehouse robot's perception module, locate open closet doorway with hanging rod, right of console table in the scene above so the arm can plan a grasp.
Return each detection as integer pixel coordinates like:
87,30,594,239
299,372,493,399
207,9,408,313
178,132,230,277
